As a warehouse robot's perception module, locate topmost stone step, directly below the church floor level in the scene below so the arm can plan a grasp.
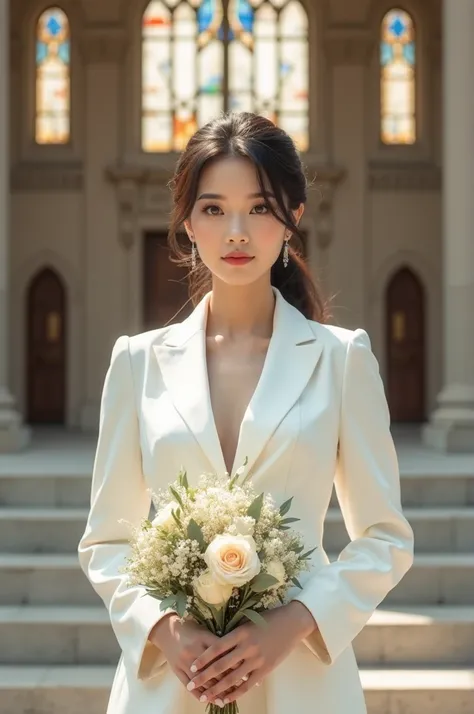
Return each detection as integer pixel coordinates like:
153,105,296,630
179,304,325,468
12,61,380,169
0,468,474,508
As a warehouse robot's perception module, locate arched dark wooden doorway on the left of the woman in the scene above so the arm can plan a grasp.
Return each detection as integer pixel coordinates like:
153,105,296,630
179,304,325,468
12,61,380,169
27,268,67,424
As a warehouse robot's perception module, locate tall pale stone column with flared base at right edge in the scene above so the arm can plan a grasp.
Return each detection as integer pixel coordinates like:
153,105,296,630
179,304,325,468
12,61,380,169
424,0,474,452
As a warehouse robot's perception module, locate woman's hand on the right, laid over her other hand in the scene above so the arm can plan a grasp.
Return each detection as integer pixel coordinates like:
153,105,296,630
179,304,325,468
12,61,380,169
184,601,316,706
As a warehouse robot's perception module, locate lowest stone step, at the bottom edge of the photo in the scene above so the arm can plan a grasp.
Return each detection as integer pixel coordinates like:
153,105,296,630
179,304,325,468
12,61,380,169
0,666,474,714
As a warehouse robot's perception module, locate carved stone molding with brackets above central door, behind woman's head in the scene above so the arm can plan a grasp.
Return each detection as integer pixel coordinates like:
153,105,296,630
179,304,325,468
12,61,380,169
106,162,345,250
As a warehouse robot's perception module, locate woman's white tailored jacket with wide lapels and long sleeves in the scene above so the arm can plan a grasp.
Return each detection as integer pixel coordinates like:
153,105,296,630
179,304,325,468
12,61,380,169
79,290,413,714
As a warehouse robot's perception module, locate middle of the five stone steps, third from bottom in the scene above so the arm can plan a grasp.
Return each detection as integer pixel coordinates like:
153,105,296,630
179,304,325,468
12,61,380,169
0,553,474,605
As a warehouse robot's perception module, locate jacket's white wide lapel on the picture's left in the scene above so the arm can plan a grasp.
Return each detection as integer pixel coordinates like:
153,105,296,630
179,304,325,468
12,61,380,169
154,293,226,474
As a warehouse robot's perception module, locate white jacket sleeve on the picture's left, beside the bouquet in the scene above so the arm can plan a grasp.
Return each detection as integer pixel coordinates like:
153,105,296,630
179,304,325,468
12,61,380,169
78,336,176,679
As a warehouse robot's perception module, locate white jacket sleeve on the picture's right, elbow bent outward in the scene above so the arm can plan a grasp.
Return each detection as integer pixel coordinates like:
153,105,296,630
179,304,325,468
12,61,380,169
294,330,413,664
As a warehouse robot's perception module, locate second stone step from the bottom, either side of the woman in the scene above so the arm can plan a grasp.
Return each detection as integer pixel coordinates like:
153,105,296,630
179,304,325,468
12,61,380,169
0,605,474,666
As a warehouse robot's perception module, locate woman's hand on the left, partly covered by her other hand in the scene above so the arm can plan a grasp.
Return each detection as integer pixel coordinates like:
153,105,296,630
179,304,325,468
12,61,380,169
149,614,224,700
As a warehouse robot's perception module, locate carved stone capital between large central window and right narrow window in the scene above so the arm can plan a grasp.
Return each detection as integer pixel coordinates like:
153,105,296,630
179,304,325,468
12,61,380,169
324,28,377,65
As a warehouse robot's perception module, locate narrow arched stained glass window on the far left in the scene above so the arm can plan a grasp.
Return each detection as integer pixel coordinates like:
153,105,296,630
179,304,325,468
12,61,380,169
35,7,71,144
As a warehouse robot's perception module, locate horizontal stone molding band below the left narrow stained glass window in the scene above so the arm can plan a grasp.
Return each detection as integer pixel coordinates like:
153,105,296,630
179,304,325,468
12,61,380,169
10,162,84,192
